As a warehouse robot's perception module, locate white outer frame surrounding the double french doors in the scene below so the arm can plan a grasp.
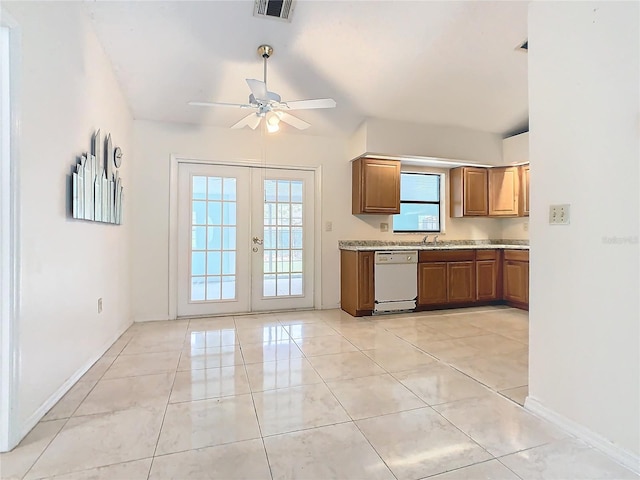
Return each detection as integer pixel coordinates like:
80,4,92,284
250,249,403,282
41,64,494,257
167,154,322,320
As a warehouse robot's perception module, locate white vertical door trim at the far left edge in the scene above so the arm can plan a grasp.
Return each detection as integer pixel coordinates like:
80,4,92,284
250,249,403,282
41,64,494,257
0,10,22,452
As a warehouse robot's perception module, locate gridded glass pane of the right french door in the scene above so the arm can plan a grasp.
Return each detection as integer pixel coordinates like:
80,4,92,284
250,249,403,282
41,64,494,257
262,180,304,297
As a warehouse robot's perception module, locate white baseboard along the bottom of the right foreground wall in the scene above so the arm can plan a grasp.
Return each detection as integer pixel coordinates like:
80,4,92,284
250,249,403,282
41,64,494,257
524,397,640,474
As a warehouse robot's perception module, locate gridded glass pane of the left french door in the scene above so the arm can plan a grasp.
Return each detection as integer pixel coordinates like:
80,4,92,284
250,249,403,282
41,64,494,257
189,175,237,302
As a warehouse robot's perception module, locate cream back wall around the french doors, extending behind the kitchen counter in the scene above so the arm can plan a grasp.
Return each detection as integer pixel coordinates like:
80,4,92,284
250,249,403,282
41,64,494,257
131,120,520,321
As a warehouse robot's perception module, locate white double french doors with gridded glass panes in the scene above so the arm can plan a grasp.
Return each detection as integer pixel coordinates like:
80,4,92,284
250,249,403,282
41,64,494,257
177,163,314,316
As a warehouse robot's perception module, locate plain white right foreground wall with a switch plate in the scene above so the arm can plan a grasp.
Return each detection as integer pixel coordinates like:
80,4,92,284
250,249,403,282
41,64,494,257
527,2,640,468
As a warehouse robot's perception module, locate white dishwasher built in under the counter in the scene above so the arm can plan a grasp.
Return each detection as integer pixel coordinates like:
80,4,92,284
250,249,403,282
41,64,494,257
373,250,418,314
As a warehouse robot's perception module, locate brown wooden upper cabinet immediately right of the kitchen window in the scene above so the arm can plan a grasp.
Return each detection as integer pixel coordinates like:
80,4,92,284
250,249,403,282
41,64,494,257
449,167,489,217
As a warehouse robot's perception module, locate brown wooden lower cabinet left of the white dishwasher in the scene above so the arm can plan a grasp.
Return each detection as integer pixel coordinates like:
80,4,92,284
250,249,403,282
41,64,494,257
340,250,375,317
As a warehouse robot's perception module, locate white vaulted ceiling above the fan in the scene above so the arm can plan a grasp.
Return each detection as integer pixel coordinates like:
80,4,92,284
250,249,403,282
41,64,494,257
85,0,528,139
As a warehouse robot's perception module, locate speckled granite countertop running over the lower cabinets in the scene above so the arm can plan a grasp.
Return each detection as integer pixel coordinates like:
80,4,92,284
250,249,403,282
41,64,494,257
338,239,529,252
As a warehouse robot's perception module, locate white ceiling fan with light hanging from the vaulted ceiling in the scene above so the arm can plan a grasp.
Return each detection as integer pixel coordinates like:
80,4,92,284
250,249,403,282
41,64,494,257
189,45,336,133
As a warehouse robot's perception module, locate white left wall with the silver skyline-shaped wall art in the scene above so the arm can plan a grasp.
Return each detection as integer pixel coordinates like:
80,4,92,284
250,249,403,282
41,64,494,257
2,2,133,434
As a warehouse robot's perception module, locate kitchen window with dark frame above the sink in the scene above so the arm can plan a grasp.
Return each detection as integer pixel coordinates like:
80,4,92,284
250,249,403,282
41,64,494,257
393,172,441,233
